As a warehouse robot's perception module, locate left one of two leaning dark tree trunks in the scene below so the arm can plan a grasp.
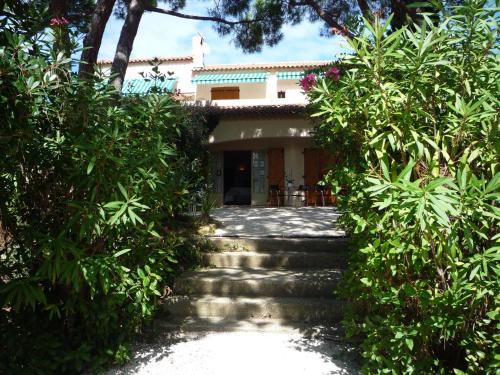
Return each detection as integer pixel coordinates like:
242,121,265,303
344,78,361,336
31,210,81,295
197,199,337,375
78,0,116,78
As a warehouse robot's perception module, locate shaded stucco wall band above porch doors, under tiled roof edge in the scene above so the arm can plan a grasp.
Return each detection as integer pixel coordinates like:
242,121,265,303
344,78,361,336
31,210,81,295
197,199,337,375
209,118,313,144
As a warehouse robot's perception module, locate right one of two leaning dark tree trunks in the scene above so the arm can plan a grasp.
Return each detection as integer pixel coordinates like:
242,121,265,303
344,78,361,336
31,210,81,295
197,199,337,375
111,0,144,93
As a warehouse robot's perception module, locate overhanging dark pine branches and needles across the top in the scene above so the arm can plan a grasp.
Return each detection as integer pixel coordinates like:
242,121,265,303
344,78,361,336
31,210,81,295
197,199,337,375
114,0,446,53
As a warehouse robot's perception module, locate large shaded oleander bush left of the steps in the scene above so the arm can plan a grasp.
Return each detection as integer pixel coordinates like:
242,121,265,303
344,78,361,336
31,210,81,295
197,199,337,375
0,26,207,374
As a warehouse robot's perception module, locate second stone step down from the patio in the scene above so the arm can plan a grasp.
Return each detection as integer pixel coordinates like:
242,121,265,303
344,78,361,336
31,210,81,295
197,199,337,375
203,251,347,268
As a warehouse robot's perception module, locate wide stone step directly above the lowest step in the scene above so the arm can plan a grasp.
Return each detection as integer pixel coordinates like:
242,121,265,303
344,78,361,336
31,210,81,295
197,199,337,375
174,268,342,297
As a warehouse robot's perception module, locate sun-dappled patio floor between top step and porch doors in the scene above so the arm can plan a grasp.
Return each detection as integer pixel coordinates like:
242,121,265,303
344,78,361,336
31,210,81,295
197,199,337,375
211,206,345,238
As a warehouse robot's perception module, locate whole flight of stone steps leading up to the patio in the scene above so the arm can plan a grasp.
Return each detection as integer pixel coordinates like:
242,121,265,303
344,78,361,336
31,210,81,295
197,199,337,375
163,237,347,329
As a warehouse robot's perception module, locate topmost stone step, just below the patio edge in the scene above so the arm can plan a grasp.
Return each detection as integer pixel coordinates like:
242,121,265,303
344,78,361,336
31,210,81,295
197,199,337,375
209,237,349,253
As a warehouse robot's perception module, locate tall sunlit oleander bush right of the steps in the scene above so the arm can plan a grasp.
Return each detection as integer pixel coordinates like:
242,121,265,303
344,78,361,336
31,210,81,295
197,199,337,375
309,0,500,374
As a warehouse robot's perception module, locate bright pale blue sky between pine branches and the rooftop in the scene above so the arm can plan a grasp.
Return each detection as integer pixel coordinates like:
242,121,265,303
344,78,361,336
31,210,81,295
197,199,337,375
99,0,345,65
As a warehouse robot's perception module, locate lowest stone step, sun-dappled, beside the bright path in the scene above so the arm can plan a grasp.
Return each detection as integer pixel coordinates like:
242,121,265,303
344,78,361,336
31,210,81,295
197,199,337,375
163,295,345,324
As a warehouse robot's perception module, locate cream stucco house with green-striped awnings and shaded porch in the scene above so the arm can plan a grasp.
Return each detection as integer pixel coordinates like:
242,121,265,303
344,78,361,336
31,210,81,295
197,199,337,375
100,35,332,205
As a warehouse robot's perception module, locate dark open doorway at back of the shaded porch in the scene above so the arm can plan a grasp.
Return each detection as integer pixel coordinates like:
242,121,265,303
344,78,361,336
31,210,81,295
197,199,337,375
224,151,252,205
